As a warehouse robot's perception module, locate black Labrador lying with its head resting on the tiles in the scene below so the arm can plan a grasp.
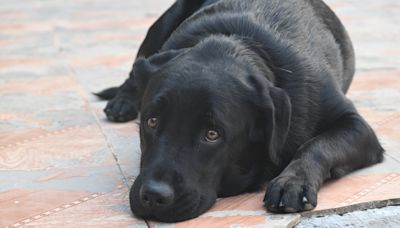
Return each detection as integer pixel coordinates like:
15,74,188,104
98,0,383,222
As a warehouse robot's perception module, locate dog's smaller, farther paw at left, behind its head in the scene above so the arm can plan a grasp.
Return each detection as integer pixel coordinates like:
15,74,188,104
104,97,138,122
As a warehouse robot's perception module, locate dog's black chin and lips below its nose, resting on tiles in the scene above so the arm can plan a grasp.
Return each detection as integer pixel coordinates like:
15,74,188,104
129,179,217,223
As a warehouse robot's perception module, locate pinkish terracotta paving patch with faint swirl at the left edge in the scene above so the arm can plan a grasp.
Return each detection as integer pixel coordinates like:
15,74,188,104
0,126,106,170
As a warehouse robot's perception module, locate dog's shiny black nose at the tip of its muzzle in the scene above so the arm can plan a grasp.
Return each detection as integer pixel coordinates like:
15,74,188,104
139,181,174,208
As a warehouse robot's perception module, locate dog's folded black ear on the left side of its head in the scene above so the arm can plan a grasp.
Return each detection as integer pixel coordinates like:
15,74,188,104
131,49,184,91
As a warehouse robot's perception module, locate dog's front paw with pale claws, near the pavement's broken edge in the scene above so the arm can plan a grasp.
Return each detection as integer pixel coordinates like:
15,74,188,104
264,176,318,213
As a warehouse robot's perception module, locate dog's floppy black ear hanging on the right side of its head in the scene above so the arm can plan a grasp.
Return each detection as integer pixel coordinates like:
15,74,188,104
263,87,291,165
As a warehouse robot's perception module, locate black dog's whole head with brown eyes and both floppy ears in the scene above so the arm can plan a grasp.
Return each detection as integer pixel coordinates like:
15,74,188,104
130,38,290,222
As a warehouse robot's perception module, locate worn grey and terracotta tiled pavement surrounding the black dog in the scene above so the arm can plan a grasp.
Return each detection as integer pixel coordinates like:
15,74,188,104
0,0,400,227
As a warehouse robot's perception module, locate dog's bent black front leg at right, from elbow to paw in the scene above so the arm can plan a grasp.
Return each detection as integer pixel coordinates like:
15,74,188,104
264,103,383,212
